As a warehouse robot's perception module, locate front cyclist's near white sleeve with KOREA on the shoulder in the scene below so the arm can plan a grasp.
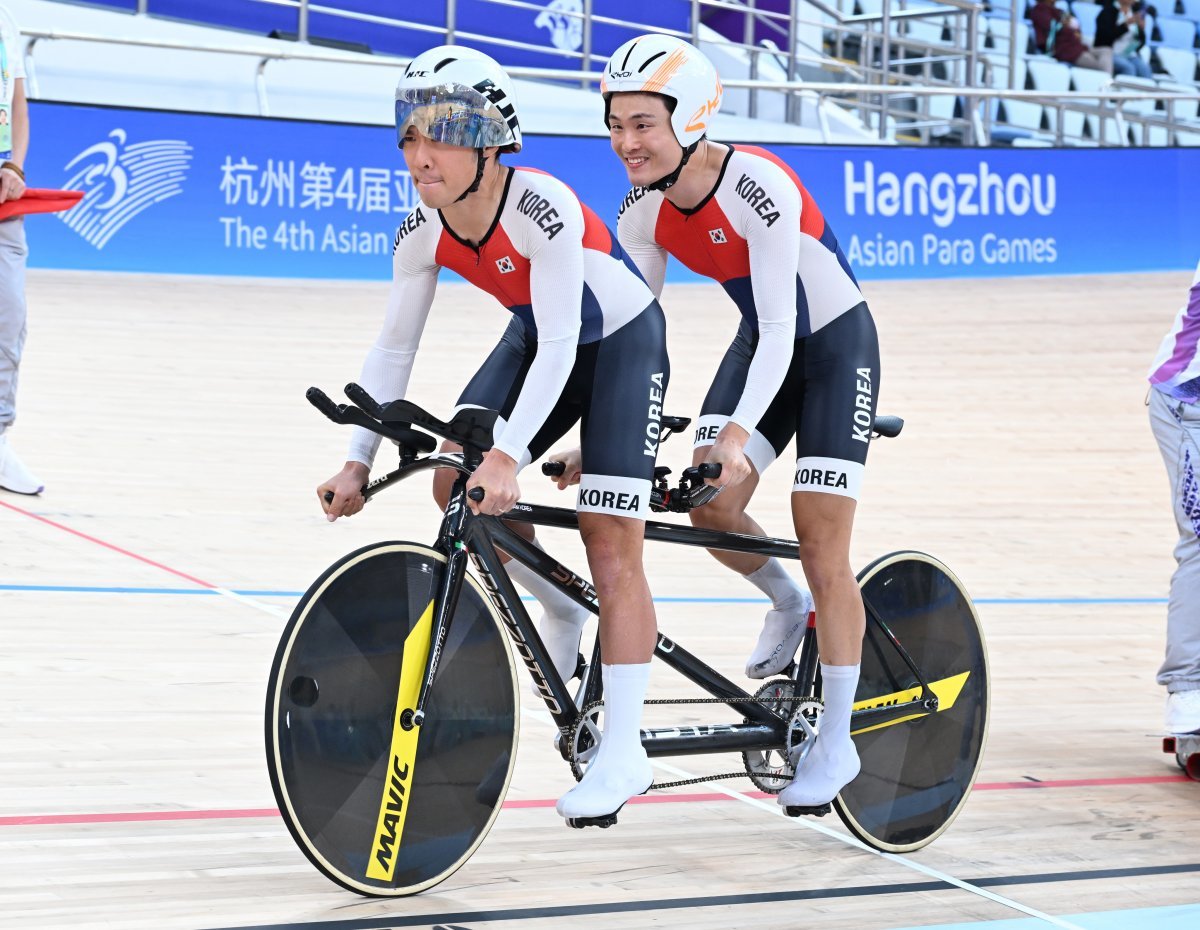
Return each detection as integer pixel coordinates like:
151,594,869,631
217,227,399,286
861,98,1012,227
493,187,583,463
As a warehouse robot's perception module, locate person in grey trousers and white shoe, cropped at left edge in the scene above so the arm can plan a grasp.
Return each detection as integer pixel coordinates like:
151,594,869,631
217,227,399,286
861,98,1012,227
0,6,42,494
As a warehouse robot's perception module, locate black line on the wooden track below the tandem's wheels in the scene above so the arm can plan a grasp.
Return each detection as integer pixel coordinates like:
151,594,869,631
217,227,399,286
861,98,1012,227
199,863,1200,930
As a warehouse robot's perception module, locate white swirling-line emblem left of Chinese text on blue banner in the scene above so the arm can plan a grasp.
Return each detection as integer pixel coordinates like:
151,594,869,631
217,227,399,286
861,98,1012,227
59,130,192,248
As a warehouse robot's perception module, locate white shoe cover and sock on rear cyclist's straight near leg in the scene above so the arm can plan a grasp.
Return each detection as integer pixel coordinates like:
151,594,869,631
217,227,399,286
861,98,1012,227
779,662,859,808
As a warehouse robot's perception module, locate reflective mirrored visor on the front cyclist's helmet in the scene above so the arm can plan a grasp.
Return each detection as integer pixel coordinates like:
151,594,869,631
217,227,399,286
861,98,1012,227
396,84,512,149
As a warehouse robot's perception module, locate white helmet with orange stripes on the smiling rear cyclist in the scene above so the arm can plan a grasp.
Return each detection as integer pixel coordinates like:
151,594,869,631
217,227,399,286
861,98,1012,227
600,34,721,149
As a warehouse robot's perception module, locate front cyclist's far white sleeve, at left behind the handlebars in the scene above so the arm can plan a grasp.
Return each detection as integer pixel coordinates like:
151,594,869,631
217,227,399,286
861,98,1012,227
347,214,438,468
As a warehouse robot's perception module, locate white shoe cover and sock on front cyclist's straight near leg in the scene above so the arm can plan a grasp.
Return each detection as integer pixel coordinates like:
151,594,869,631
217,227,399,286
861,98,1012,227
556,662,654,818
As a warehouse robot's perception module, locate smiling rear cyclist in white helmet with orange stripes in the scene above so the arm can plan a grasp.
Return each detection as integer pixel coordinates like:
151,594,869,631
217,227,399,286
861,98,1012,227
566,35,880,809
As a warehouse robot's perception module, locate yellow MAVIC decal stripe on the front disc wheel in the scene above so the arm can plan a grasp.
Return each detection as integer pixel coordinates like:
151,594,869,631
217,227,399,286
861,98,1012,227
367,601,433,882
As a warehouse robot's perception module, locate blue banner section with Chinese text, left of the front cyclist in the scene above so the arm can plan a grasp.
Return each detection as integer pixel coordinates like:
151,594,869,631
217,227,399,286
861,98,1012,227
30,103,419,278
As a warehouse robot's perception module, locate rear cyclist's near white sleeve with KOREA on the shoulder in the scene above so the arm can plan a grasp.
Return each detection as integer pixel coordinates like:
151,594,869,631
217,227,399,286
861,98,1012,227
730,164,800,432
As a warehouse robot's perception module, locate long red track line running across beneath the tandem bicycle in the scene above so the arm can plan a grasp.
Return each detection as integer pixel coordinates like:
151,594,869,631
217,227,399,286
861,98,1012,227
0,775,1192,827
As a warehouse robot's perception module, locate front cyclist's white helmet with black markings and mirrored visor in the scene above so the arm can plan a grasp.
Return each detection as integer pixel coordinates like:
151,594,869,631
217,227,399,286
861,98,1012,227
396,46,521,151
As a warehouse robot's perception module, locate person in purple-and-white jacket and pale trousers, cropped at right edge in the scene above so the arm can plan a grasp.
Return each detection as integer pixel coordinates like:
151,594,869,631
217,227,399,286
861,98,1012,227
1148,258,1200,734
